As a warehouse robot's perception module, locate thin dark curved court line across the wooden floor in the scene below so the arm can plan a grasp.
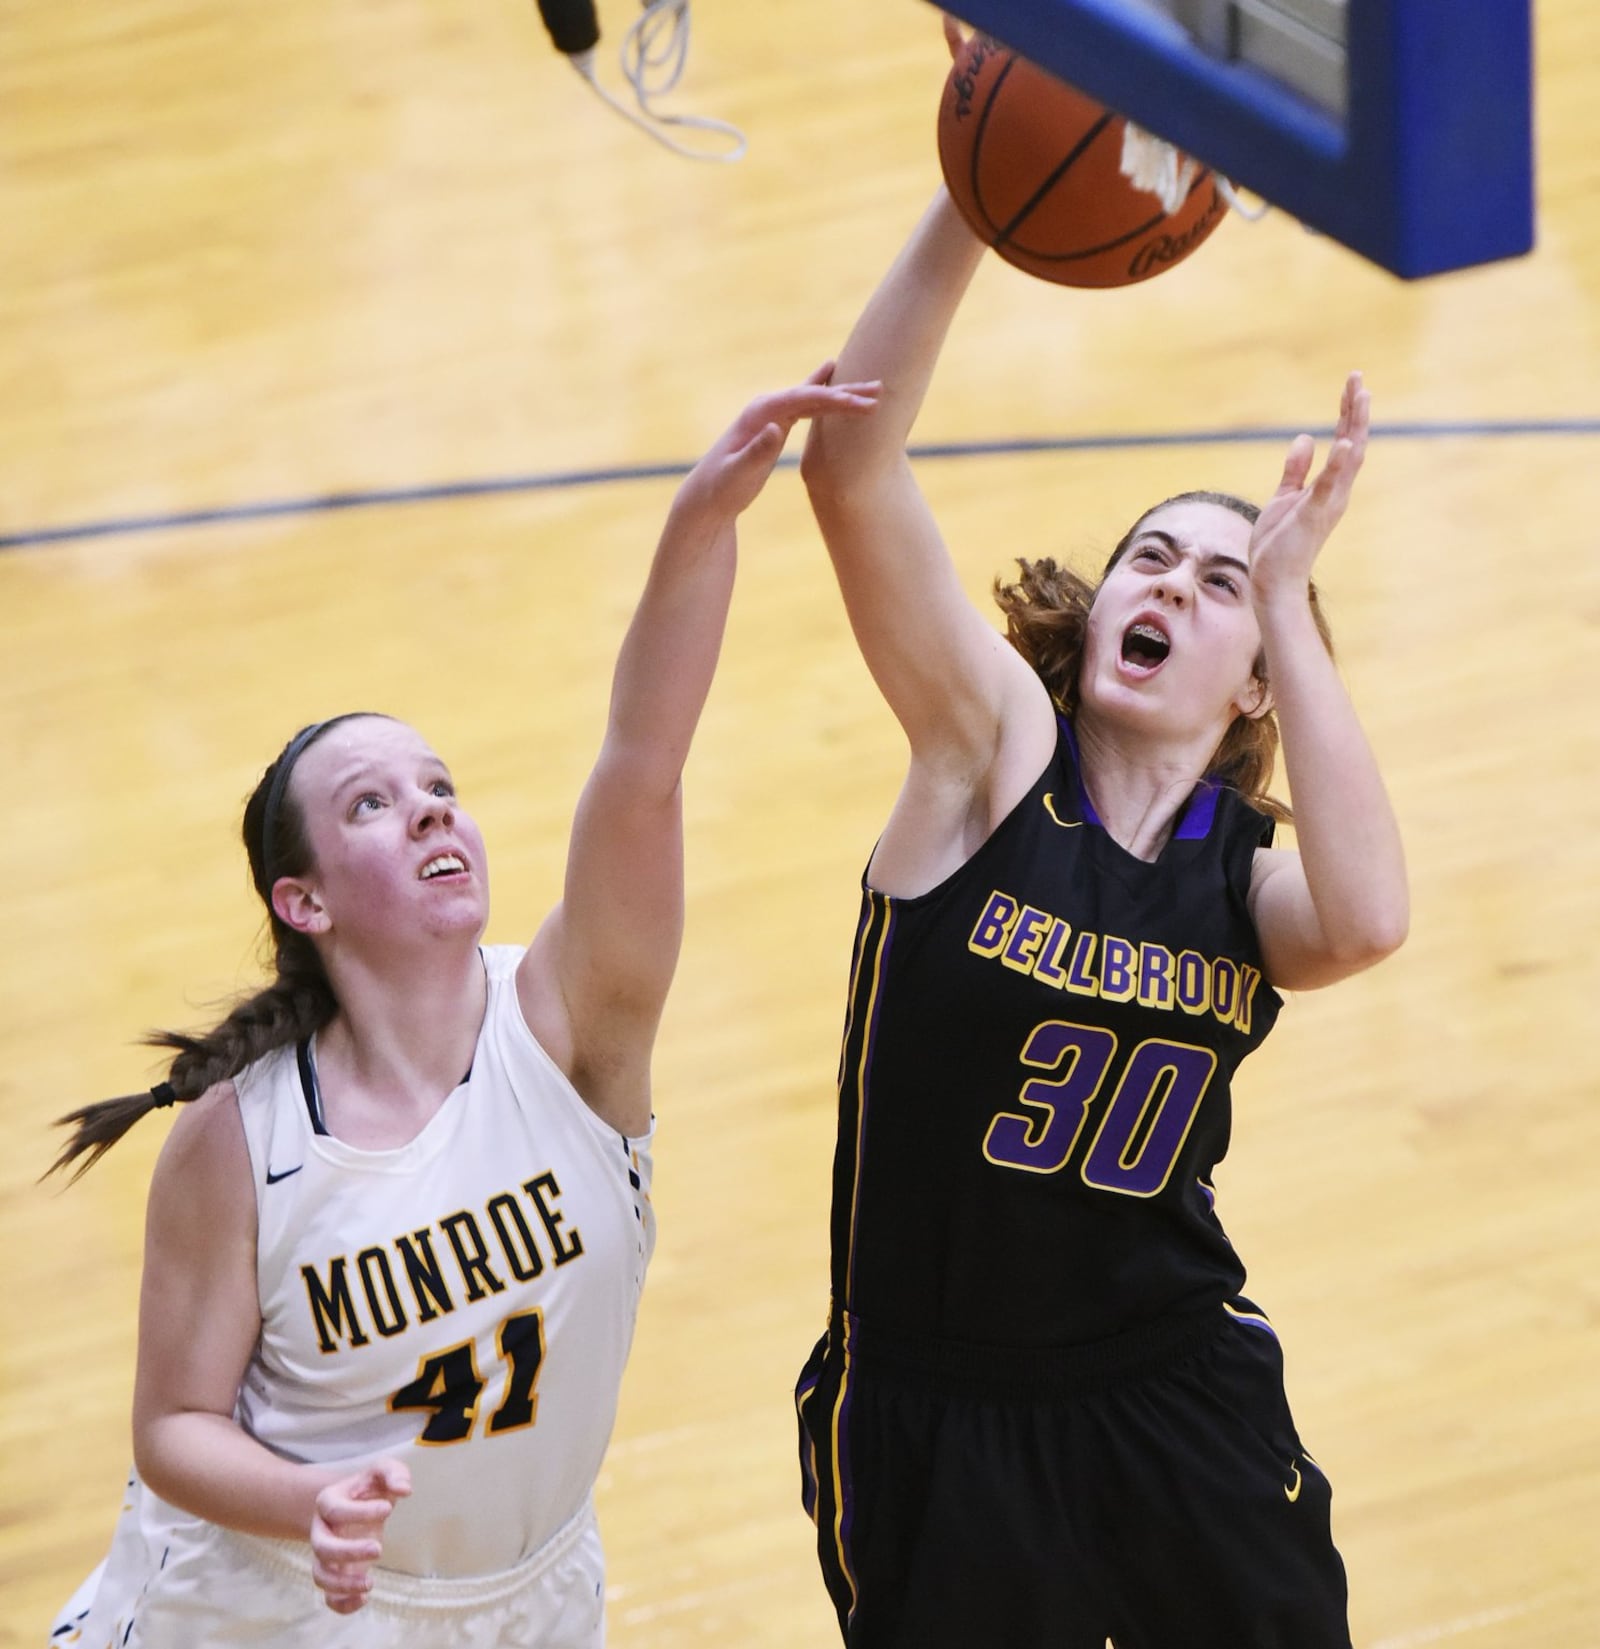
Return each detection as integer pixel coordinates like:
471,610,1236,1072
0,417,1600,551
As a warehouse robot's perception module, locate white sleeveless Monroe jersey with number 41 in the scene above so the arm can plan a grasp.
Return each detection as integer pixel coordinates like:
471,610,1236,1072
234,947,655,1575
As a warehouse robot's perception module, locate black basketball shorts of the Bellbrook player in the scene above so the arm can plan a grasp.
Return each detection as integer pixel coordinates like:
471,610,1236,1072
795,1299,1349,1649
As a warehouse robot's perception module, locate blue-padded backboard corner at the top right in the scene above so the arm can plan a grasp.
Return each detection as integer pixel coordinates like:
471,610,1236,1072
945,0,1534,279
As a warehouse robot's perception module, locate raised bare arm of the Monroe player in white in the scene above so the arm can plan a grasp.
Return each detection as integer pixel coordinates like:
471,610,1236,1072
518,371,876,1135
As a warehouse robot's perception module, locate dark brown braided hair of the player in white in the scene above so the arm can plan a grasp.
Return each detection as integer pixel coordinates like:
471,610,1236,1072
46,711,373,1181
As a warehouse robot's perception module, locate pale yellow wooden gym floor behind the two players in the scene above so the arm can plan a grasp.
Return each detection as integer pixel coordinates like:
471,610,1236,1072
0,0,1600,1649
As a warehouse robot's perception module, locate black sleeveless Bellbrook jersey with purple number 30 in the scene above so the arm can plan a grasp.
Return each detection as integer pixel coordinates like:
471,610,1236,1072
831,719,1280,1347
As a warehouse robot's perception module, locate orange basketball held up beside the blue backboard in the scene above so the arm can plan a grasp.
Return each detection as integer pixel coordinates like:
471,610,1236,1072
939,33,1227,287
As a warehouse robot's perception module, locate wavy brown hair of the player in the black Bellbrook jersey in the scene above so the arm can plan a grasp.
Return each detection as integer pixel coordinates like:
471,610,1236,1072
995,491,1333,825
